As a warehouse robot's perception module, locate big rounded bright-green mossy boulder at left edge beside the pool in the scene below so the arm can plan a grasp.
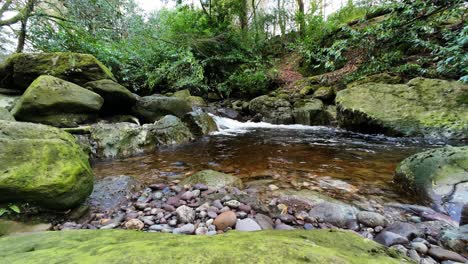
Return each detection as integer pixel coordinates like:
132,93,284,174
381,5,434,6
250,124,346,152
0,121,93,209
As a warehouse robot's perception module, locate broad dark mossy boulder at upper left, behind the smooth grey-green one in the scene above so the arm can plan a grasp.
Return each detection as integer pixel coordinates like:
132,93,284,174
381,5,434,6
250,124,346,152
0,52,114,91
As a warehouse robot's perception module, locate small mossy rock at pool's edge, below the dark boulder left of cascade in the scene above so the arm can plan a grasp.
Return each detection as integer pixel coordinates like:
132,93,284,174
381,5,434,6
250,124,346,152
147,115,195,145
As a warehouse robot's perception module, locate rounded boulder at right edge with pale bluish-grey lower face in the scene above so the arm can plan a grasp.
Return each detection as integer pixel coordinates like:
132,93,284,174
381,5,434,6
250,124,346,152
395,147,468,221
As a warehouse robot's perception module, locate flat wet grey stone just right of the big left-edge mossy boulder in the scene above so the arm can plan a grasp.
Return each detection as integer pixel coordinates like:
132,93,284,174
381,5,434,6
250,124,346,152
87,175,138,212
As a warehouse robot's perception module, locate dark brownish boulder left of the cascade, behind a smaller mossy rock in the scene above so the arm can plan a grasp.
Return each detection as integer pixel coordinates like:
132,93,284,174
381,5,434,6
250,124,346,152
133,95,192,123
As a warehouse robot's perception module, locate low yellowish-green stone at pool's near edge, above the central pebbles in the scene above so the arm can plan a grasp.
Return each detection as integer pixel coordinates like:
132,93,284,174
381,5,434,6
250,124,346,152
180,170,242,189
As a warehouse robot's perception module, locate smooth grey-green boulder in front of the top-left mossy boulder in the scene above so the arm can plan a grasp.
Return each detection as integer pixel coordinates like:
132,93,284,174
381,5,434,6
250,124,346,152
12,75,104,127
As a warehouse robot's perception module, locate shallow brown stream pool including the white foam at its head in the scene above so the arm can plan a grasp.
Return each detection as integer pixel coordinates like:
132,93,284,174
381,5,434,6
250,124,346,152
94,117,433,205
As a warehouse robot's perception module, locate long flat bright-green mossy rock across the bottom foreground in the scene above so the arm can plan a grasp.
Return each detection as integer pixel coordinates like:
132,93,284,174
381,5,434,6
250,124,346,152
0,229,409,264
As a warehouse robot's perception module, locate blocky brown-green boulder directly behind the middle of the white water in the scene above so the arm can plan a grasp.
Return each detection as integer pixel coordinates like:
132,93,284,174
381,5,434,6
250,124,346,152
249,95,294,124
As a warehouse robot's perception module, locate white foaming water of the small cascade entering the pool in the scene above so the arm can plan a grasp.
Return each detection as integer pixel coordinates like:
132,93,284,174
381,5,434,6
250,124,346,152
210,114,333,135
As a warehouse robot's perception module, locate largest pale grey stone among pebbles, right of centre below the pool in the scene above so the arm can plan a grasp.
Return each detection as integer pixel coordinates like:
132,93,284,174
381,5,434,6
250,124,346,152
309,202,358,228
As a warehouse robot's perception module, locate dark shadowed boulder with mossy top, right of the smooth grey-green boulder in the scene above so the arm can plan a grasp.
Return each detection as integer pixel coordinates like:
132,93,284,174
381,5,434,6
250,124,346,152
83,79,137,114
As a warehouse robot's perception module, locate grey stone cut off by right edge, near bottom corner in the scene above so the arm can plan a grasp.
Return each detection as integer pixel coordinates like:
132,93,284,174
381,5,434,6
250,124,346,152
440,225,468,256
